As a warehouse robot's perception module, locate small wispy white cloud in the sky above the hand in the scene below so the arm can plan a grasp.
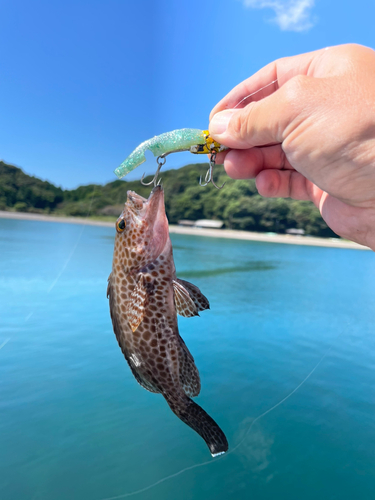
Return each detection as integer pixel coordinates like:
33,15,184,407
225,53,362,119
242,0,315,31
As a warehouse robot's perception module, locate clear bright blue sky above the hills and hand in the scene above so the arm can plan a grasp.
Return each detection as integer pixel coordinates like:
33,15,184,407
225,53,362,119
0,0,375,188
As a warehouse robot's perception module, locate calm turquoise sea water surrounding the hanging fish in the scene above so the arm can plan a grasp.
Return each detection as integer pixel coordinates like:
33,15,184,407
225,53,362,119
0,219,375,500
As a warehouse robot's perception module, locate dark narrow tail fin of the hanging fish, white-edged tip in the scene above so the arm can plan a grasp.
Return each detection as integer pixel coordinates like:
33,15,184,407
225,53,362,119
163,393,228,457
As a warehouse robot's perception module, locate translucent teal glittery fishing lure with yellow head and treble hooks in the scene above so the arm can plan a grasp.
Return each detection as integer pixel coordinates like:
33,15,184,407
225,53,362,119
115,128,227,189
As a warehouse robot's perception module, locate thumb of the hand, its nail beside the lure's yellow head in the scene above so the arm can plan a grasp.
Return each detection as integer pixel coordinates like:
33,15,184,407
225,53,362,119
209,76,310,149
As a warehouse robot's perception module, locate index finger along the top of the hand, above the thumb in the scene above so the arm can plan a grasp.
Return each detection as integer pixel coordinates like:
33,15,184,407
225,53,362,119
210,49,325,120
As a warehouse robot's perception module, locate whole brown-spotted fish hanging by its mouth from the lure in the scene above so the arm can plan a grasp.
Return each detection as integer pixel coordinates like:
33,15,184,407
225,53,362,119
107,186,228,456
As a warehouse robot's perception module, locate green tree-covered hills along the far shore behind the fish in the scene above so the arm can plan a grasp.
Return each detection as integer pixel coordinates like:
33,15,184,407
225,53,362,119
0,161,335,237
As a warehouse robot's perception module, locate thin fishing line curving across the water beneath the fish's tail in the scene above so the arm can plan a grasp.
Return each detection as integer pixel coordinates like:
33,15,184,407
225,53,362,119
101,333,341,500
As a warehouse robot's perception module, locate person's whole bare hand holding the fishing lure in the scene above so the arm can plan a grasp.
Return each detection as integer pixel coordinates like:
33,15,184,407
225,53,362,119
210,44,375,250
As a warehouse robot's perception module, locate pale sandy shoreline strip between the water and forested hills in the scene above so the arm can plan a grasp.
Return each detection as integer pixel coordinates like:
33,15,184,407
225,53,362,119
0,210,370,250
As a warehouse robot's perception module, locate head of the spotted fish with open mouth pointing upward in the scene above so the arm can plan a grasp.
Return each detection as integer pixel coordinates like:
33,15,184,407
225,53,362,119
115,186,170,272
